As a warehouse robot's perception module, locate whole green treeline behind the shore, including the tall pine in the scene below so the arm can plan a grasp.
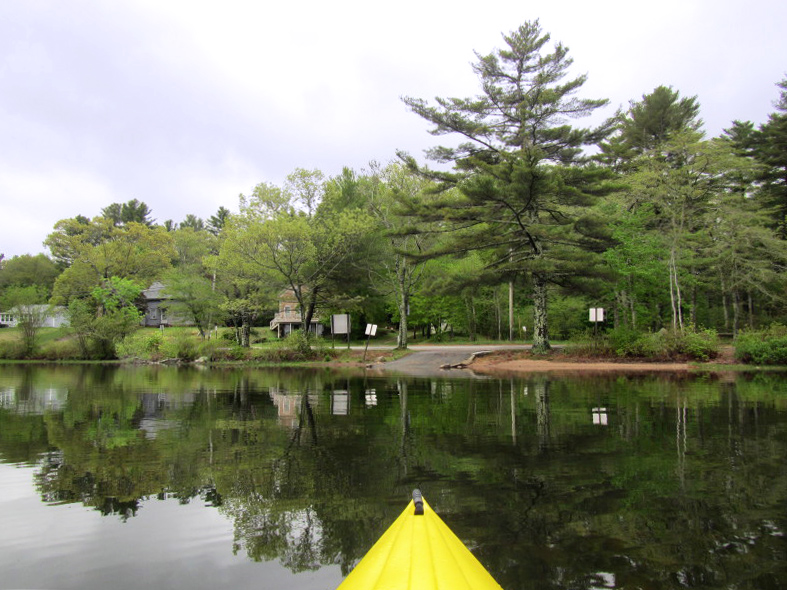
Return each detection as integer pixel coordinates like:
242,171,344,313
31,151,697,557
0,21,787,356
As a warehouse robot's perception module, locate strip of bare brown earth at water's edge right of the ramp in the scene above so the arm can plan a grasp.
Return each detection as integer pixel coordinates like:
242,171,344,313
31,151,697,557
470,347,734,375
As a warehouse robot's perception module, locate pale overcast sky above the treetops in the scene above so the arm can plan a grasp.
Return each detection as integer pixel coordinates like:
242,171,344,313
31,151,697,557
0,0,787,257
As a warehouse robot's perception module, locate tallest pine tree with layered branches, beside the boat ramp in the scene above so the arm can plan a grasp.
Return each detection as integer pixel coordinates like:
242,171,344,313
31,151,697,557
402,21,610,351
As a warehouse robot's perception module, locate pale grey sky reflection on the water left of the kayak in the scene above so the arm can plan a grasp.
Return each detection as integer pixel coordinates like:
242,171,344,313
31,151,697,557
0,464,341,590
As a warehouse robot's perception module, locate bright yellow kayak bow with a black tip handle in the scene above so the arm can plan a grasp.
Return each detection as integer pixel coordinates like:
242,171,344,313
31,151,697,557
337,490,502,590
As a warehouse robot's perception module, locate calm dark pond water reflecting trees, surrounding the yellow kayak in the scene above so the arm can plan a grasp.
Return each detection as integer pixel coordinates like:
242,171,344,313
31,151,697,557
0,366,787,590
